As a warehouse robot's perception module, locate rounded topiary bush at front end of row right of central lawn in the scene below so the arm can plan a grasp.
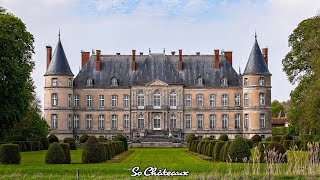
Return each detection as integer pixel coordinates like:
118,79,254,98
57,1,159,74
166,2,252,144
228,137,251,162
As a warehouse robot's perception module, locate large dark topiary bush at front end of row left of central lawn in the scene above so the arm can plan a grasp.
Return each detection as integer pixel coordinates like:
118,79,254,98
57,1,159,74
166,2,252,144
82,136,106,164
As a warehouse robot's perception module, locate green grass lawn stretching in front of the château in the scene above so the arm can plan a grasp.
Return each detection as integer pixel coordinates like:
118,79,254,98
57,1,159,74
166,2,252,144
0,148,318,180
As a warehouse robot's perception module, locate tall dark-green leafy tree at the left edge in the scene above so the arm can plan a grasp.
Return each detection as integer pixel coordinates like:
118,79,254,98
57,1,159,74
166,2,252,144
0,8,34,139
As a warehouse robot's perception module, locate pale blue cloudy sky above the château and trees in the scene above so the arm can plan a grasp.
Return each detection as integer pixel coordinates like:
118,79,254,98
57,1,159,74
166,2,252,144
0,0,320,105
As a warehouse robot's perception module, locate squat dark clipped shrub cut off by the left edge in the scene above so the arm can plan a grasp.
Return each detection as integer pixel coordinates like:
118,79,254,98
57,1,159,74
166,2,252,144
0,144,21,164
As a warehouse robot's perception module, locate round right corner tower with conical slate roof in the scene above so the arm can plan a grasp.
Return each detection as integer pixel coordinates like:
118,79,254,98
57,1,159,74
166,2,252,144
242,35,272,138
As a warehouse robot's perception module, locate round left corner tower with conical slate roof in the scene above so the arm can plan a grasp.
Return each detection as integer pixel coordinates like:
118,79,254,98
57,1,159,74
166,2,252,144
44,32,73,139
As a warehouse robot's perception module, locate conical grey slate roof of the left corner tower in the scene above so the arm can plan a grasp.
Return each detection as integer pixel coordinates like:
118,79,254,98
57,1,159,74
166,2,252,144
44,37,73,76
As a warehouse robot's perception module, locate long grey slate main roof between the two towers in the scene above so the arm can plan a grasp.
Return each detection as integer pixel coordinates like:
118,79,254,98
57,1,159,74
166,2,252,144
74,54,240,88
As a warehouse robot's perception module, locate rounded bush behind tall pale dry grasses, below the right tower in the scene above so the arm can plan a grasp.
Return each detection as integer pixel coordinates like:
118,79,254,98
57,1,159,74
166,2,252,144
264,141,287,163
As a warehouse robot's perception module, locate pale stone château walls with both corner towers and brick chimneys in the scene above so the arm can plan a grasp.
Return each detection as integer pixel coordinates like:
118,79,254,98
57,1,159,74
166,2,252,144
44,35,272,139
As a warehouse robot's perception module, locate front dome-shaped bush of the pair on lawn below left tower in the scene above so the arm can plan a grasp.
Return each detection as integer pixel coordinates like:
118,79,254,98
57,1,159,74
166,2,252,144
45,142,66,164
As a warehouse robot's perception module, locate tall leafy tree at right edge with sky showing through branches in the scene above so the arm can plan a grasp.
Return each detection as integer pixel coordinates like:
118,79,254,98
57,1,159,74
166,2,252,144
282,15,320,133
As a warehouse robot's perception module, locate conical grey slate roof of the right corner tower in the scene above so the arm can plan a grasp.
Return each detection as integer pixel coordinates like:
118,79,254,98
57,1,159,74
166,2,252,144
243,38,270,75
